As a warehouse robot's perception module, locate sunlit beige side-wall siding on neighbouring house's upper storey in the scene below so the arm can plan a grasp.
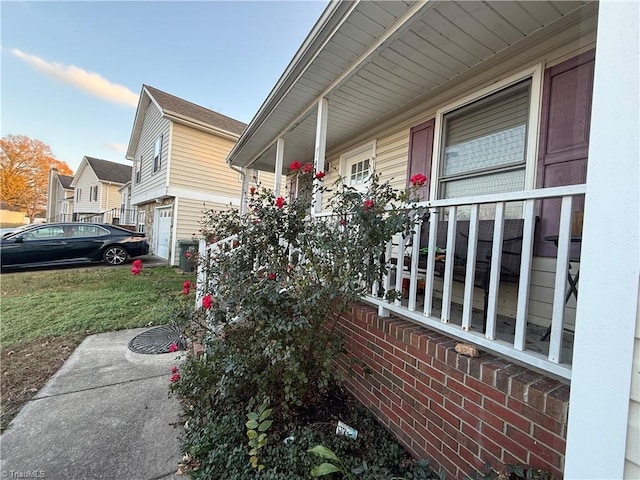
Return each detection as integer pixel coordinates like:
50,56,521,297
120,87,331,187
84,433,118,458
169,123,242,199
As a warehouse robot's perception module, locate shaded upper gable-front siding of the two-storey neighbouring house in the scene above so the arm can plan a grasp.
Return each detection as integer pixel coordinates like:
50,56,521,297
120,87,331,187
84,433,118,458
131,102,170,204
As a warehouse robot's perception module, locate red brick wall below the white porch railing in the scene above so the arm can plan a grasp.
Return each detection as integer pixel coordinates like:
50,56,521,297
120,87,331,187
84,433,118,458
341,304,569,479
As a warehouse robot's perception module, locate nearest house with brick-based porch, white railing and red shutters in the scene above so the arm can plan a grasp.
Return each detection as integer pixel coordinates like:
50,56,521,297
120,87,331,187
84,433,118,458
221,0,640,479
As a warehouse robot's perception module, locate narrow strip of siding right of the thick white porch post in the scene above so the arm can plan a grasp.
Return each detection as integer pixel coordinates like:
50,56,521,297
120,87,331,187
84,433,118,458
624,298,640,478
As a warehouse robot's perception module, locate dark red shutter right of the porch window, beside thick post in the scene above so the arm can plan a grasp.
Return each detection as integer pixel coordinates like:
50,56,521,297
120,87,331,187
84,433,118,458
536,50,595,256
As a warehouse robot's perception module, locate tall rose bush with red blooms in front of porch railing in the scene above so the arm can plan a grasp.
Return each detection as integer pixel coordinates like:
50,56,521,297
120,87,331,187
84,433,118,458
172,162,424,415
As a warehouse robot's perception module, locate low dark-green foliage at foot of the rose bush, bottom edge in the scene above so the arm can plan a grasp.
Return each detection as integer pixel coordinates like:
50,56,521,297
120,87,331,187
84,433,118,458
178,390,440,480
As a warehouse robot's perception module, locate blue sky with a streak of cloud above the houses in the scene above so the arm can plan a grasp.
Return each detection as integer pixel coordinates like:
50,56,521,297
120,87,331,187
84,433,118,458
0,0,327,171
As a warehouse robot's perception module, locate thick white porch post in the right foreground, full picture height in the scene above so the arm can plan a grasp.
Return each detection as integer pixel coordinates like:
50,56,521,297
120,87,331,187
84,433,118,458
565,0,640,479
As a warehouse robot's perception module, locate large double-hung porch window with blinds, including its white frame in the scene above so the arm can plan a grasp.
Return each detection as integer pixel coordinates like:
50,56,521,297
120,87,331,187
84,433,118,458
431,65,542,217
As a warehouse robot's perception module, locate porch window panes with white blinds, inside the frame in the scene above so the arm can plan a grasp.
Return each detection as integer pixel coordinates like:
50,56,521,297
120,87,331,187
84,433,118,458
438,80,531,198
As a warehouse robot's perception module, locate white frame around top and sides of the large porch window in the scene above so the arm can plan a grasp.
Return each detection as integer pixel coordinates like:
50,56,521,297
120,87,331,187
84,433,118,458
430,63,543,200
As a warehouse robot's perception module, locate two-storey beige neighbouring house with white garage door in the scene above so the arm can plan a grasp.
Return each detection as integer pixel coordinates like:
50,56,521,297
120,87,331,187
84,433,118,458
127,85,272,265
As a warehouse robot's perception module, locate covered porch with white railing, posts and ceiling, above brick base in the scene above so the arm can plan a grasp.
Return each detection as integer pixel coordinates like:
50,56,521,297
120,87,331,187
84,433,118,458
218,1,640,478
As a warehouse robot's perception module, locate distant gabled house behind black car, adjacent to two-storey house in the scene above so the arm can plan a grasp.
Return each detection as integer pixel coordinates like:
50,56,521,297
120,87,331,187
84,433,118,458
70,156,131,223
